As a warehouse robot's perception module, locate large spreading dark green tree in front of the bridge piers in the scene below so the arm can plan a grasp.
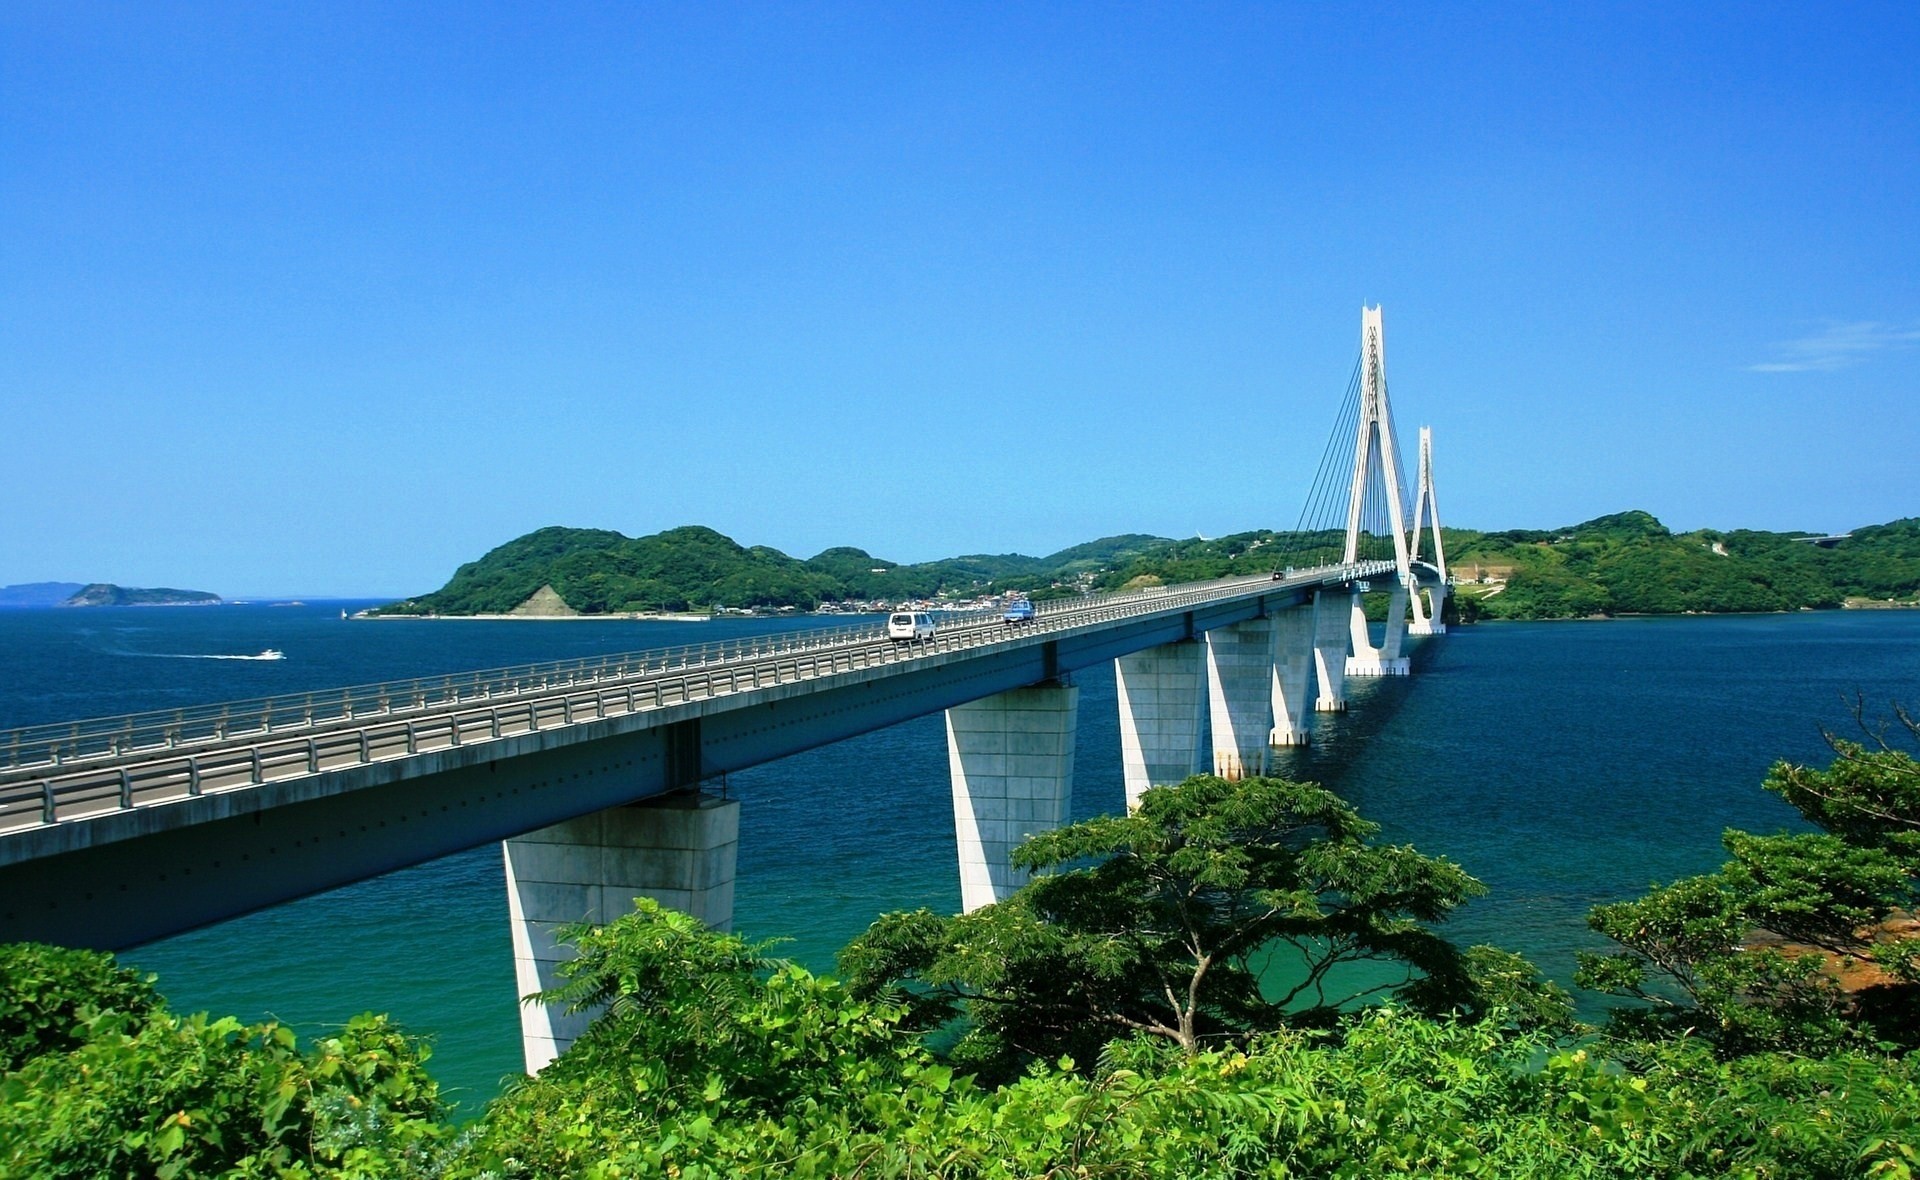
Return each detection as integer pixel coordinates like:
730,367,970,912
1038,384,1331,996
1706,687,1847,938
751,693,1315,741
841,775,1565,1074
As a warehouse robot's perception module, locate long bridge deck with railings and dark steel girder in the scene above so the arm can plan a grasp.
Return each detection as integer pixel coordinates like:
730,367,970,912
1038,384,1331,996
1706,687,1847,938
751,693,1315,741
0,562,1394,950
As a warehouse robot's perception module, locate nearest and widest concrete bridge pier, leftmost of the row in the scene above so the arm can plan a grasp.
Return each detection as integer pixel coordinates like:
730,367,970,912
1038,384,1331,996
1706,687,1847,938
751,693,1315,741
503,792,739,1074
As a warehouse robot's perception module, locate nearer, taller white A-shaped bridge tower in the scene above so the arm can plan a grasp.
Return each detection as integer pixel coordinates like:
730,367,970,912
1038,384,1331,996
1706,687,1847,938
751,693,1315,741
1344,305,1415,675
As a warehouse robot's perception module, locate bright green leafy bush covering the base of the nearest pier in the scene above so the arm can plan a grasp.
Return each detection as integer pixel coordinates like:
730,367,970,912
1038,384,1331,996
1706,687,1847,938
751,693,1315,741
451,898,927,1176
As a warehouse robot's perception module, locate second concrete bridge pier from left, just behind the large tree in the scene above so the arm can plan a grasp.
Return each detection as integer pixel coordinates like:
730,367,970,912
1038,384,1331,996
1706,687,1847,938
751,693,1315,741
947,683,1079,913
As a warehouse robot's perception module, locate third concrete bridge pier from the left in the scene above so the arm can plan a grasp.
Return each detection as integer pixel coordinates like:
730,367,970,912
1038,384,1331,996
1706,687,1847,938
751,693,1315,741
1114,639,1206,812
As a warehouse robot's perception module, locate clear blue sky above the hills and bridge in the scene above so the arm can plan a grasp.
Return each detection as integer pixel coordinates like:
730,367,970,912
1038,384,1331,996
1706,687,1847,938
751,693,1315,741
0,0,1920,595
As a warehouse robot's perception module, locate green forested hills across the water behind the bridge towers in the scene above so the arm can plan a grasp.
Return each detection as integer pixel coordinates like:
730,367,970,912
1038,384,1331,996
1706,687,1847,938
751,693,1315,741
367,510,1920,620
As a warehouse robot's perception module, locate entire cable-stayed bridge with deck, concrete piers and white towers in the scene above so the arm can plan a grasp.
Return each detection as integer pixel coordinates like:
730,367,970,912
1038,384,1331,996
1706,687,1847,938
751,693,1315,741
0,307,1448,1071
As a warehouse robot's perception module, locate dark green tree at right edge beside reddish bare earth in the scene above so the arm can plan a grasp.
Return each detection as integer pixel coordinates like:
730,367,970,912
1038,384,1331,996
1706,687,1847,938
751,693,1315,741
1576,714,1920,1055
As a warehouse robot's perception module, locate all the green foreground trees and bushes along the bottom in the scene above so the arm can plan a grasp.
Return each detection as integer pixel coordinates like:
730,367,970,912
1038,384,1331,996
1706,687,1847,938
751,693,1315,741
0,714,1920,1180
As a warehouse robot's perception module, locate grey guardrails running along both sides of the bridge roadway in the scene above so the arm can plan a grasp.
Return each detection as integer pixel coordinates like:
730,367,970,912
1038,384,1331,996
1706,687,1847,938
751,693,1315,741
0,562,1390,831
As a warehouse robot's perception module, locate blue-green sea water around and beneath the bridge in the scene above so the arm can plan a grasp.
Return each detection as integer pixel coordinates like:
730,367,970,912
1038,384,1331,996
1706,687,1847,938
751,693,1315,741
0,602,1920,1109
